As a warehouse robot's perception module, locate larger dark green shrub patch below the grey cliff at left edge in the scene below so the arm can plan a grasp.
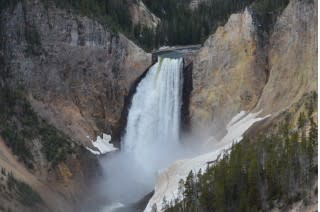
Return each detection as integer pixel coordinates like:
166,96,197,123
0,88,73,169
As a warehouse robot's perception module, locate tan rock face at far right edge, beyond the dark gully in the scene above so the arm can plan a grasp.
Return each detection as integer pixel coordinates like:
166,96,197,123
257,0,318,113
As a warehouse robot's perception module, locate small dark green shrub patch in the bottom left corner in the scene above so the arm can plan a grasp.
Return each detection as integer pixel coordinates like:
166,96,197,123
7,173,42,206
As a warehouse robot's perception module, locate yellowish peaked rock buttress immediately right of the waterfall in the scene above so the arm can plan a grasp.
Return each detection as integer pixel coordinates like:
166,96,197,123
190,9,267,136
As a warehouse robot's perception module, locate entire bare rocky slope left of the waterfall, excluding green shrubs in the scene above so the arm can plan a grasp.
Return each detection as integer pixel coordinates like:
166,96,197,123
0,0,151,211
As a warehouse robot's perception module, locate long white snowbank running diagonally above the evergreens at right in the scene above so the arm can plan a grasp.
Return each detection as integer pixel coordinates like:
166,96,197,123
144,111,270,212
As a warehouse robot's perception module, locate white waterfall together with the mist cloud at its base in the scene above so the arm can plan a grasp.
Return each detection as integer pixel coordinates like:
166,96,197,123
102,57,183,207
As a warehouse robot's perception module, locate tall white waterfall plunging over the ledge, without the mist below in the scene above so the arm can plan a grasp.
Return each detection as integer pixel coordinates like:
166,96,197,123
122,57,183,170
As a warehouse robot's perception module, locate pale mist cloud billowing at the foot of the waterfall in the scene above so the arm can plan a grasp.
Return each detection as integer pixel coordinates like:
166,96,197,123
99,137,197,205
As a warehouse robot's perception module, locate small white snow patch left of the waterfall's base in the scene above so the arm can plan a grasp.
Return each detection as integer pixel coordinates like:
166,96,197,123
86,133,118,155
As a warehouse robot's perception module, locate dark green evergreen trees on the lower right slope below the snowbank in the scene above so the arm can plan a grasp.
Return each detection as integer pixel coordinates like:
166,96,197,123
164,112,318,212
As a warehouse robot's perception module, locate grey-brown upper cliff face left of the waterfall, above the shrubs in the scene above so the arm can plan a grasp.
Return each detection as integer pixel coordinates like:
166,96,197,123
0,0,151,144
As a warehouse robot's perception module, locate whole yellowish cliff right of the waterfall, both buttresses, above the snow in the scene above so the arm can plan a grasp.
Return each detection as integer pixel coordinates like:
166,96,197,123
190,0,317,138
